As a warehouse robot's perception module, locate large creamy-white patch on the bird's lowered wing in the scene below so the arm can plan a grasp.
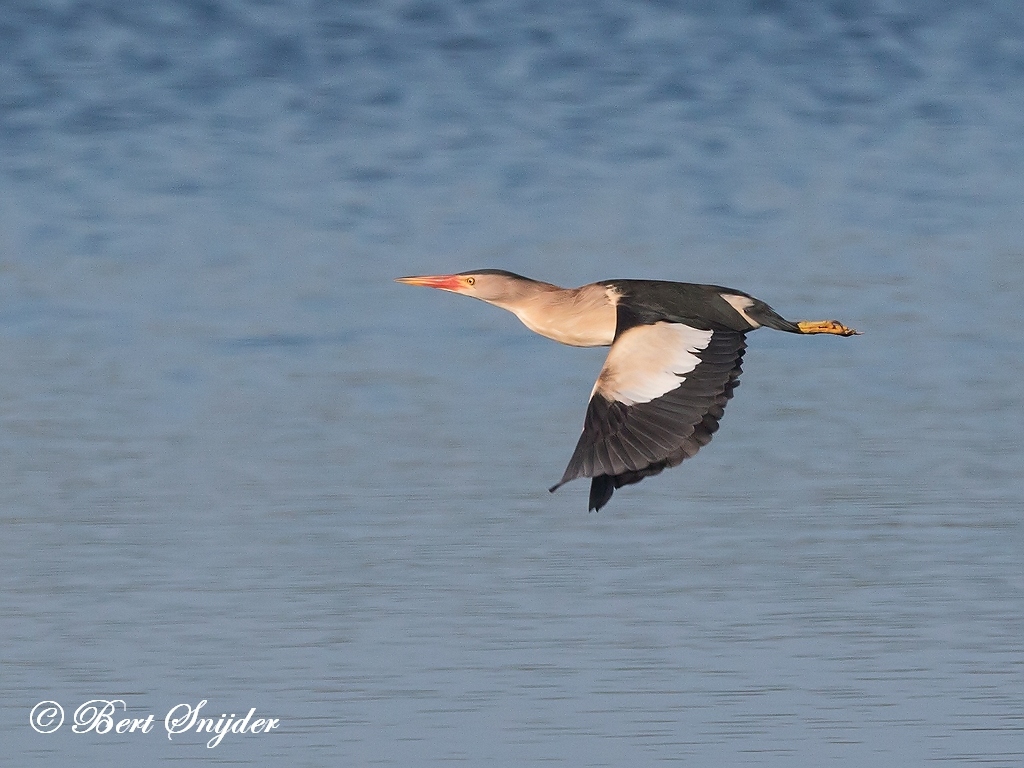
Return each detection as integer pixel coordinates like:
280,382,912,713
591,323,712,406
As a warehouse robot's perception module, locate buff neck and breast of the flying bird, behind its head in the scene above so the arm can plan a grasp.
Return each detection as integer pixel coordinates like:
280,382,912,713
495,283,617,347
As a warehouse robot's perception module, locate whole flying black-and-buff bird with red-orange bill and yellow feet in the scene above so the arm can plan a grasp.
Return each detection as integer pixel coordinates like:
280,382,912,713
396,269,859,510
